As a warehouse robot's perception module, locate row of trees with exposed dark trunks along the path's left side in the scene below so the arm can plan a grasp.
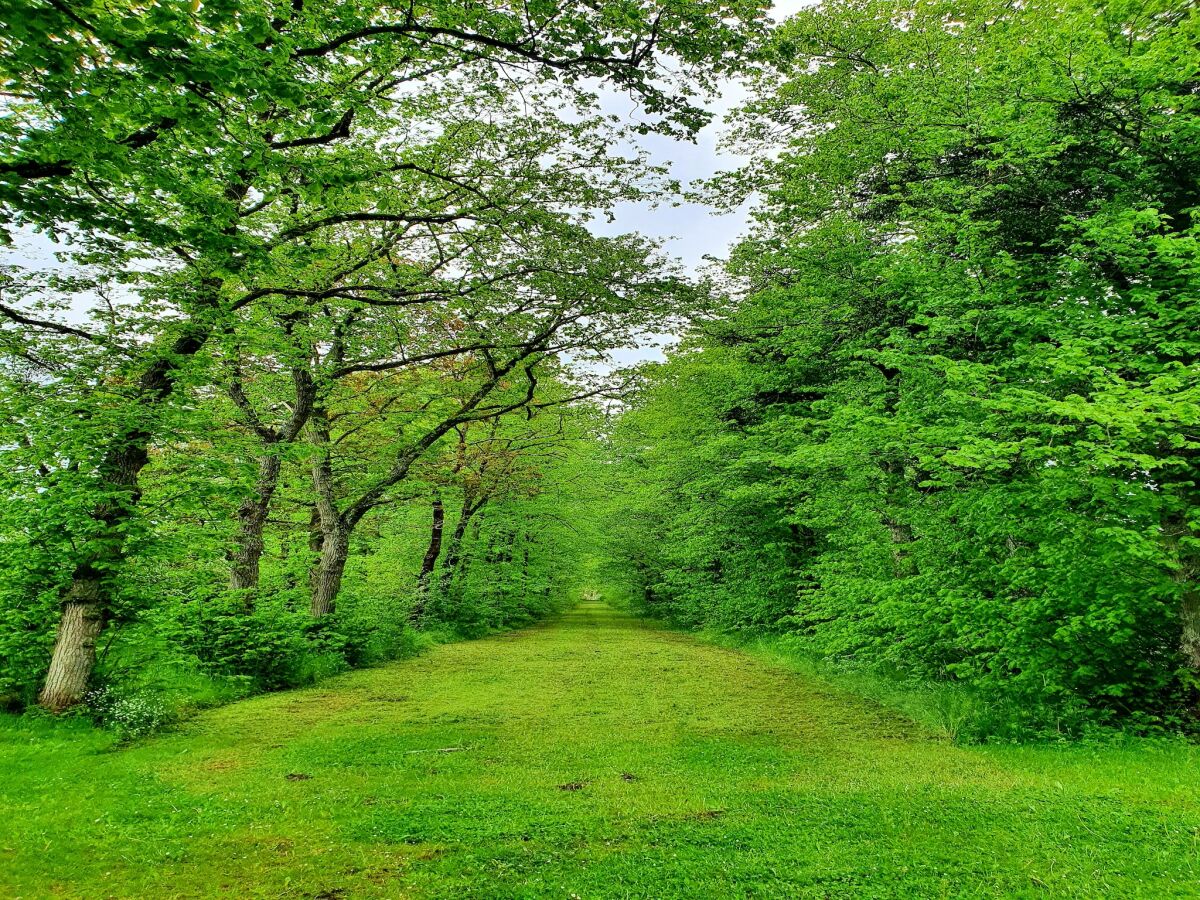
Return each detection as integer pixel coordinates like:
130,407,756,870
0,0,761,710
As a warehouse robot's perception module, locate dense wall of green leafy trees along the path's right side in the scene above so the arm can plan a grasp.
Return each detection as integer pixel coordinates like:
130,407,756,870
604,0,1200,731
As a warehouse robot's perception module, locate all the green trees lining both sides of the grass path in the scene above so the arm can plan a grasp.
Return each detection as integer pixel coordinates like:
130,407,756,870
0,0,1200,736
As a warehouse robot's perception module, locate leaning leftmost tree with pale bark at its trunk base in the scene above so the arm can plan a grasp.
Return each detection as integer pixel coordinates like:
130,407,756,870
0,0,760,709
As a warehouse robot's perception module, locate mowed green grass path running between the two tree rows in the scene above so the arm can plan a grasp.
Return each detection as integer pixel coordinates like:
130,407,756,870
0,602,1200,899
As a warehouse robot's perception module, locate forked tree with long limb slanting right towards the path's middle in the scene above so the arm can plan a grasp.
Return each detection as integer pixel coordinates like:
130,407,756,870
300,221,696,617
